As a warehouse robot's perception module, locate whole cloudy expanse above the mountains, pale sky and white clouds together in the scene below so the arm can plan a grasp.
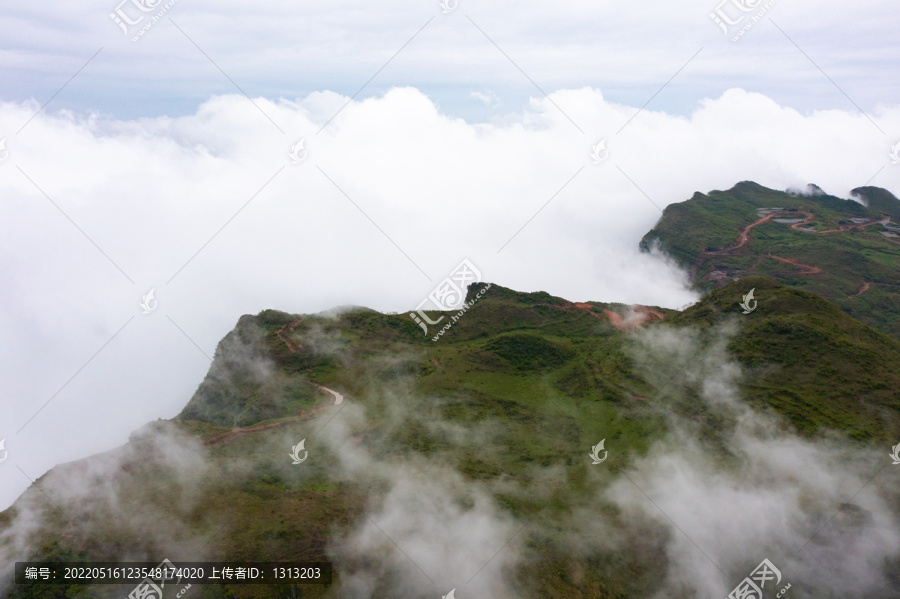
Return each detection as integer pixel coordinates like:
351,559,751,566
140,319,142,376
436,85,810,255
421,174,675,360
0,0,900,509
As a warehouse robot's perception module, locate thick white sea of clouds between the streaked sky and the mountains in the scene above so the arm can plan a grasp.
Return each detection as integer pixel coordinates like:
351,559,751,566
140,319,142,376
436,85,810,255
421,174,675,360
0,88,900,516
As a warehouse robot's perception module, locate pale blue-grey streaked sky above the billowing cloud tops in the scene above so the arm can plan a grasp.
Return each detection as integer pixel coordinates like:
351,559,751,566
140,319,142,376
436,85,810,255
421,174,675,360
0,0,900,121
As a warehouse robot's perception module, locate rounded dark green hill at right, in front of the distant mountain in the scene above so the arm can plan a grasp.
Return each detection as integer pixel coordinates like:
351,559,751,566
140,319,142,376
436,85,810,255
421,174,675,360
670,276,900,442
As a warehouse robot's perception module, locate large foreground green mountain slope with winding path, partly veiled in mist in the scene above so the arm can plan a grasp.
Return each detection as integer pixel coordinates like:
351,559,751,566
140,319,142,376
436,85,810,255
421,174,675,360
0,276,900,599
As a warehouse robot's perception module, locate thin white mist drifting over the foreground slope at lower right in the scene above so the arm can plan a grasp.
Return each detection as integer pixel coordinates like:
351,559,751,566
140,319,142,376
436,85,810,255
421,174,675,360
605,322,900,597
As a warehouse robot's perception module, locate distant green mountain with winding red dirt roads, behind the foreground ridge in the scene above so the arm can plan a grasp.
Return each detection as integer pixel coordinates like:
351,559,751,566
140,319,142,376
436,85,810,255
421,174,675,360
641,182,900,338
